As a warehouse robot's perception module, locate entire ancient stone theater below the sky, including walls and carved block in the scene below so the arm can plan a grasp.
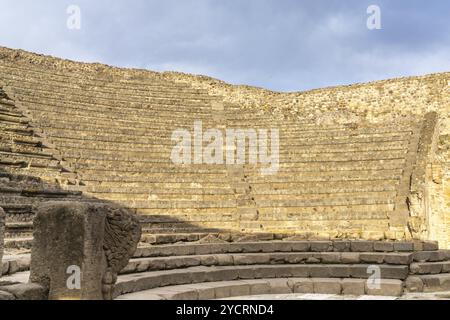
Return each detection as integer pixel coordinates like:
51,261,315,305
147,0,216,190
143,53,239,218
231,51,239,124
0,48,450,300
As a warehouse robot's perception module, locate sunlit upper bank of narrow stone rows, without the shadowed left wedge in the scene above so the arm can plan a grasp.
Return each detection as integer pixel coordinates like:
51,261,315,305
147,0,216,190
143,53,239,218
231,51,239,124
0,52,428,244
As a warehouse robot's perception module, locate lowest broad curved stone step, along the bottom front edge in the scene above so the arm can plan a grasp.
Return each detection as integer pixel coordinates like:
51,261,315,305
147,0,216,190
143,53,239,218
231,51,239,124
116,278,403,301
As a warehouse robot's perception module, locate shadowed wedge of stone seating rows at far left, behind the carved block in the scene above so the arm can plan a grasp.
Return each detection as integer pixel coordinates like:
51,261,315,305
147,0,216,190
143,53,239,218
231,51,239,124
0,90,86,248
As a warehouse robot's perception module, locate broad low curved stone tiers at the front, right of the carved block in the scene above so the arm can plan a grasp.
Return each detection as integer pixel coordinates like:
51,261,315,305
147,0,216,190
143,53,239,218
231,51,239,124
116,241,450,300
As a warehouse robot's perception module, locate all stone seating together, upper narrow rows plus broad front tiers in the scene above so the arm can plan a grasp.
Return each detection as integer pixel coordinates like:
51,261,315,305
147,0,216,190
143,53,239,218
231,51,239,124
0,49,449,299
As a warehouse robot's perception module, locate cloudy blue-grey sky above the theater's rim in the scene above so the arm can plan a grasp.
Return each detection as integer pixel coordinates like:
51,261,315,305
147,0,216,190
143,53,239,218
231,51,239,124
0,0,450,91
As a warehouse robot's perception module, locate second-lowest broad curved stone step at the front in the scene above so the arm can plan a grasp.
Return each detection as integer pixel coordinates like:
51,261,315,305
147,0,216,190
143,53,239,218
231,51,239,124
114,264,408,297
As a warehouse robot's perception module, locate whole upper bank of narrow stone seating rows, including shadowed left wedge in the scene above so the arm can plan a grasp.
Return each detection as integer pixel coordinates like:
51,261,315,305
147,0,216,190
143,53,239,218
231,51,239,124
0,49,444,247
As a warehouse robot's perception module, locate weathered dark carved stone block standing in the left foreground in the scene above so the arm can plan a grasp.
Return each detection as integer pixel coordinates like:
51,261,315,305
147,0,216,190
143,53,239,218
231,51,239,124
30,202,141,300
